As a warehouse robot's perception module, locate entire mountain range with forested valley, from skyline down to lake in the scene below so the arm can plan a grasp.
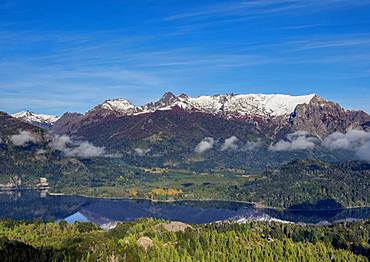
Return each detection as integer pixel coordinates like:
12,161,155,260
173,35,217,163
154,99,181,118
0,93,370,207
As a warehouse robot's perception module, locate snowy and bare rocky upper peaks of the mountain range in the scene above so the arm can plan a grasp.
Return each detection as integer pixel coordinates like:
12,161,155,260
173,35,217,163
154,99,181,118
13,92,370,138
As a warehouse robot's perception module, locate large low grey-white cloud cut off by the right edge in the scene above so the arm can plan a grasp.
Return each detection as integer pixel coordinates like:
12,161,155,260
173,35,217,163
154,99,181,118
322,129,370,161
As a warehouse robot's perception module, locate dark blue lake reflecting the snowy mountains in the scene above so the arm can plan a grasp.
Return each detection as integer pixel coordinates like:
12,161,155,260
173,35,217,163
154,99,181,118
0,190,370,227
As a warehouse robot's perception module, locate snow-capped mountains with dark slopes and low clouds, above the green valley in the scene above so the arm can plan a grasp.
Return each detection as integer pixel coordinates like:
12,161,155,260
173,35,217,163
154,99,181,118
0,92,370,170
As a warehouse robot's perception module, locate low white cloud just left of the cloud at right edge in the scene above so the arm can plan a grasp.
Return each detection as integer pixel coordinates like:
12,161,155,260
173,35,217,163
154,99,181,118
269,131,319,151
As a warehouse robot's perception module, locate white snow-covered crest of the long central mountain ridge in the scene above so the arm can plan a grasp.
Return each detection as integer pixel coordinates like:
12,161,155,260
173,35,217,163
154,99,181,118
88,92,315,117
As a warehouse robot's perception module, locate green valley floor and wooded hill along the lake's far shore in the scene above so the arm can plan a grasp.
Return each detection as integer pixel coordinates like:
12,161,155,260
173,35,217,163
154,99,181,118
55,161,370,209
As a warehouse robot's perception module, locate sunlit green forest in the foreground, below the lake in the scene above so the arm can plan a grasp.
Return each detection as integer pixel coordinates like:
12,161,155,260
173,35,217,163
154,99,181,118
0,219,370,261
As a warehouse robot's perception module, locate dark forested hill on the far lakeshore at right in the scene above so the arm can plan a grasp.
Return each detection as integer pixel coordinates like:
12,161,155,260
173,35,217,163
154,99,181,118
237,160,370,208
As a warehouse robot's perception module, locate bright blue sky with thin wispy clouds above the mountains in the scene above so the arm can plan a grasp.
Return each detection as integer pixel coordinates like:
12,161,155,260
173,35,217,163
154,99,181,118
0,0,370,114
